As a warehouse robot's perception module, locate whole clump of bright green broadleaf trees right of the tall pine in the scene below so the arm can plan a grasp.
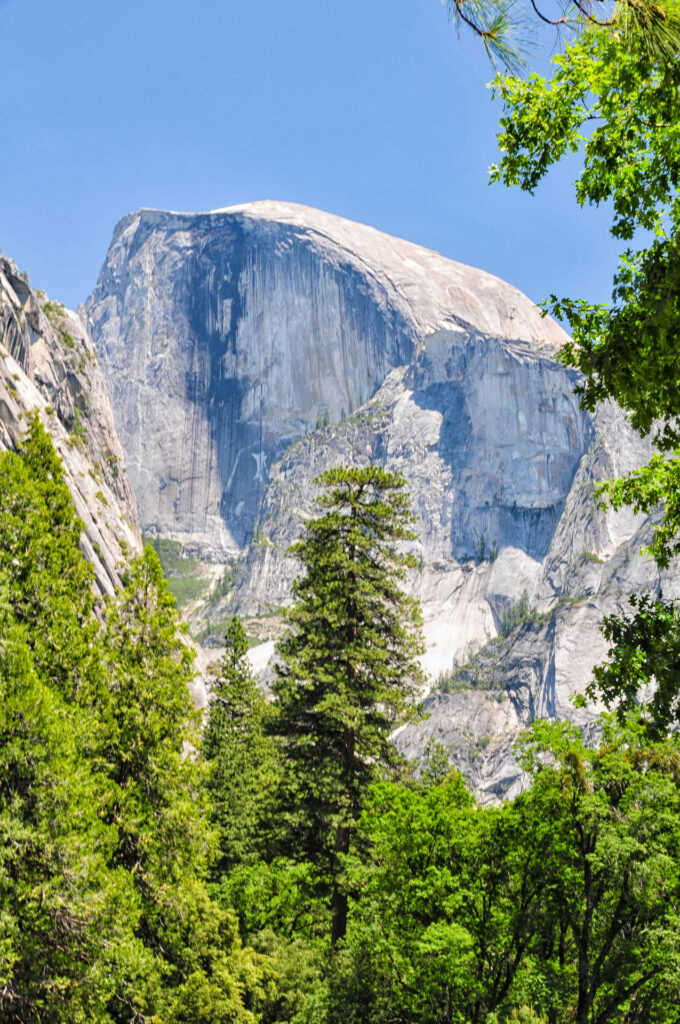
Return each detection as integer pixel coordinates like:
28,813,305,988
325,723,680,1024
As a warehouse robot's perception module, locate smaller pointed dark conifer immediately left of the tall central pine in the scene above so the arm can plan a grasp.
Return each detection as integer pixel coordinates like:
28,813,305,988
202,615,275,880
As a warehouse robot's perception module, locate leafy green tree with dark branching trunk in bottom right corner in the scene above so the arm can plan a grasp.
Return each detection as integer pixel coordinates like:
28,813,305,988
522,722,680,1022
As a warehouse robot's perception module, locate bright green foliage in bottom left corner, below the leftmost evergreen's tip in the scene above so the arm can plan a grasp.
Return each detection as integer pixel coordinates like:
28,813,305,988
0,585,148,1024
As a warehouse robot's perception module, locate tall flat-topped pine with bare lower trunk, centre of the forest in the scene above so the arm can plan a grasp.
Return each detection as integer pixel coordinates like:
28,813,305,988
272,466,423,945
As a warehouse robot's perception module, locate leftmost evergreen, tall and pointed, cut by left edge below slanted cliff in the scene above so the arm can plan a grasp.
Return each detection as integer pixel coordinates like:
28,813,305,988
0,434,150,1024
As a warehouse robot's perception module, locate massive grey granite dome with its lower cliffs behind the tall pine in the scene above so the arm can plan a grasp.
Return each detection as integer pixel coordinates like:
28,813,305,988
85,202,663,800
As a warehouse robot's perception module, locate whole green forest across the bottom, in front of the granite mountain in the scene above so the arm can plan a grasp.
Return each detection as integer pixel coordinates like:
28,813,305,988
0,418,680,1024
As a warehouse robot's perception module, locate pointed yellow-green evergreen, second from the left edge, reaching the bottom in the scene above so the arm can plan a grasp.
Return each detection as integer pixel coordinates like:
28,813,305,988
99,546,264,1024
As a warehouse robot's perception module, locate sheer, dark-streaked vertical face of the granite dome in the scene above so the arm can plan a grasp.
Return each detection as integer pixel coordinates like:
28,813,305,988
85,200,417,556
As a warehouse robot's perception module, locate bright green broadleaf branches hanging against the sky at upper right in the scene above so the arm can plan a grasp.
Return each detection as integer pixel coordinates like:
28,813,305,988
492,32,680,512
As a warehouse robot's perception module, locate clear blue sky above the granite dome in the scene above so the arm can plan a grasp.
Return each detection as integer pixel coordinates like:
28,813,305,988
0,0,614,306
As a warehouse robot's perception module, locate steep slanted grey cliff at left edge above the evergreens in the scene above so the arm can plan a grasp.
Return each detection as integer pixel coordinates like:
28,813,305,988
0,257,140,594
